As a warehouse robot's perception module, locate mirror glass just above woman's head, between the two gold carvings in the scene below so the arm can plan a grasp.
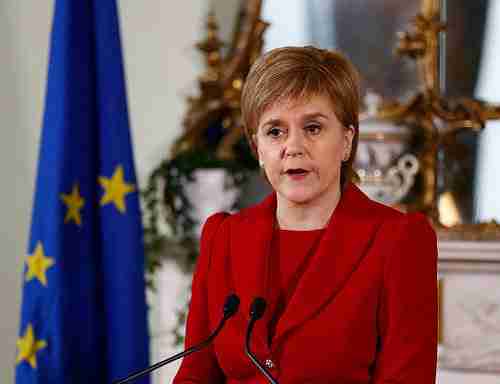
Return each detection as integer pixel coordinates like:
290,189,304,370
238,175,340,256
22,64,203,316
262,0,420,98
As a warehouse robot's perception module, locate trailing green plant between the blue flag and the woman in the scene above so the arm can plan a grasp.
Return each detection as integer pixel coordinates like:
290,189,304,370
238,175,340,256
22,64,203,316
142,150,254,344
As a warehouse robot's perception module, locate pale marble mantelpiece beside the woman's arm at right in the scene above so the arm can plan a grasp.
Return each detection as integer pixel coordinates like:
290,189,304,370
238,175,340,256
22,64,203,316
438,241,500,382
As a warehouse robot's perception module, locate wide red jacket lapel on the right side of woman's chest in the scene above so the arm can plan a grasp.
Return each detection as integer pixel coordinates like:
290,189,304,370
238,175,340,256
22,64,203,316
275,184,379,340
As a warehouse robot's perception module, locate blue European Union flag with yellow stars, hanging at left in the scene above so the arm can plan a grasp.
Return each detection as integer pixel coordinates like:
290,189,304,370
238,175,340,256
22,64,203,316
16,0,149,384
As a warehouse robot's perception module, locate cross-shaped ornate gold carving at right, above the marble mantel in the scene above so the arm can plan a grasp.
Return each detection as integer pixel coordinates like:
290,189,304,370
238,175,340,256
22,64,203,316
377,0,500,239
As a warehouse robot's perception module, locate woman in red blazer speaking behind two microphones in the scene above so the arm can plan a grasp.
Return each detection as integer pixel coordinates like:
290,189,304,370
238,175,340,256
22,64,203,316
174,47,437,384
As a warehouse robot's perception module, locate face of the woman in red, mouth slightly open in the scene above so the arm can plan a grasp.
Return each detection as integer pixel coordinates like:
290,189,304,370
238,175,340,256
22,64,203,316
254,95,354,205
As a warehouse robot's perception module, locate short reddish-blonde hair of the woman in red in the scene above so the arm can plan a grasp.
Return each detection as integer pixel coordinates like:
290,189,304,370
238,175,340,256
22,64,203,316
241,46,360,185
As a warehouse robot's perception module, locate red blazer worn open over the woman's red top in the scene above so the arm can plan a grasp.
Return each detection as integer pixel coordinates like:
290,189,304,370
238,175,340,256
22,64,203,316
174,184,437,384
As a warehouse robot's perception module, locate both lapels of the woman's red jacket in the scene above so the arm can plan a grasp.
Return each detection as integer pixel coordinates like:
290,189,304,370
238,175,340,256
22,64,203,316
230,184,379,347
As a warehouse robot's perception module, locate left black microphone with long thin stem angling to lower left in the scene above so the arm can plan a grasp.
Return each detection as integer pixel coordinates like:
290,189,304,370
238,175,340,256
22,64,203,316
113,293,240,384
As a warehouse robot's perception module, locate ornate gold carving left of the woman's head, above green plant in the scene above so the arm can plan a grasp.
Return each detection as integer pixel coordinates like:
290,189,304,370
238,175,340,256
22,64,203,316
172,0,268,159
